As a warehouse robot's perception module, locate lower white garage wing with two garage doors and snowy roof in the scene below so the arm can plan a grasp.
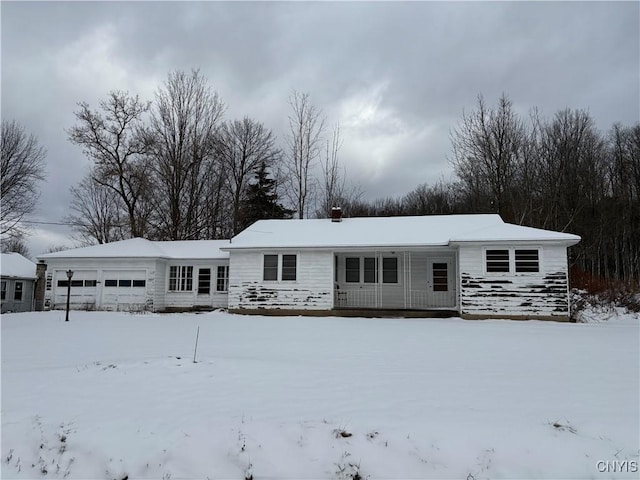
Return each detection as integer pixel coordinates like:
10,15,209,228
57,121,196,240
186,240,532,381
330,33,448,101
38,238,229,311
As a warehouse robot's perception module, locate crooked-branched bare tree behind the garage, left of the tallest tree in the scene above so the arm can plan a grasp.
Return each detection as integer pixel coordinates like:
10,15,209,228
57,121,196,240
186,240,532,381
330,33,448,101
68,91,149,237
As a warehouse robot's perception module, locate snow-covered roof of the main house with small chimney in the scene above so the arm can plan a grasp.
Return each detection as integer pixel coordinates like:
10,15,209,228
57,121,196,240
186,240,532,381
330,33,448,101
224,214,580,250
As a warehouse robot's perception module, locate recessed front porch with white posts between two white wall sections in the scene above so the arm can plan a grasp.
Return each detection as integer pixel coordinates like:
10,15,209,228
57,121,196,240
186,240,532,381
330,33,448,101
334,248,458,312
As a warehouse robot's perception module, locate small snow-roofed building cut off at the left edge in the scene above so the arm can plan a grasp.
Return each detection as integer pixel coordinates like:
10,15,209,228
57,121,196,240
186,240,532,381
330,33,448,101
0,253,36,313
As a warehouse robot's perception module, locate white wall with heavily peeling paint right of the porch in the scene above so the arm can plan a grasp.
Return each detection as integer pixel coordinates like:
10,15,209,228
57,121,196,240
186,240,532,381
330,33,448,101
459,243,569,317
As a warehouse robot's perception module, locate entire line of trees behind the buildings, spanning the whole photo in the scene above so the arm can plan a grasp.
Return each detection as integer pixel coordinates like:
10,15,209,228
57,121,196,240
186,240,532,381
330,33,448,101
1,70,640,281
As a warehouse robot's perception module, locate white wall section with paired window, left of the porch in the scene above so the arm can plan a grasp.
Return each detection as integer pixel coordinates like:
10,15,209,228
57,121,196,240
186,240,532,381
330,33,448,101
229,250,333,310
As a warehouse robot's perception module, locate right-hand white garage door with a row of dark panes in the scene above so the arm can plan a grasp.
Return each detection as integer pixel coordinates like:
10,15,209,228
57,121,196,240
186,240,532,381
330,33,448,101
102,270,147,310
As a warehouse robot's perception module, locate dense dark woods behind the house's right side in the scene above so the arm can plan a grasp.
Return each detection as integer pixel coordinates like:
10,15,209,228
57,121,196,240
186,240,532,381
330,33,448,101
346,95,640,284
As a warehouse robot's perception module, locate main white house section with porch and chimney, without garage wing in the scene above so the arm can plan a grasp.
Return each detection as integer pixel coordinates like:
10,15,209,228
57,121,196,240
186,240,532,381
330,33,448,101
222,210,580,320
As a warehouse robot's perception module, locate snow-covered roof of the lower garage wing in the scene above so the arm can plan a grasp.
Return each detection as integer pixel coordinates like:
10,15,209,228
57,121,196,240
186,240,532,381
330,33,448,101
38,238,229,260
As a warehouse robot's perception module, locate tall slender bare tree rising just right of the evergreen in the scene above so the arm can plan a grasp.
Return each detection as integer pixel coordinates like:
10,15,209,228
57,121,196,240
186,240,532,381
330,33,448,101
285,90,324,218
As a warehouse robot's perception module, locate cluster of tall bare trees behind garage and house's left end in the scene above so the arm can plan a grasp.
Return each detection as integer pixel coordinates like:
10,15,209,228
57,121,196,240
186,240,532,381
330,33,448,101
67,70,360,243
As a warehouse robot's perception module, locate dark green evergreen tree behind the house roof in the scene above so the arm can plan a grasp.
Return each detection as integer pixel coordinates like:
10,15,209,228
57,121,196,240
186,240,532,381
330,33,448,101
239,162,295,230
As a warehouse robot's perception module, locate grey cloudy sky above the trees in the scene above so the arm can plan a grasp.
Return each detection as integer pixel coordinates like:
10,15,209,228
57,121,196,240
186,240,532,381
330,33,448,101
0,1,640,255
